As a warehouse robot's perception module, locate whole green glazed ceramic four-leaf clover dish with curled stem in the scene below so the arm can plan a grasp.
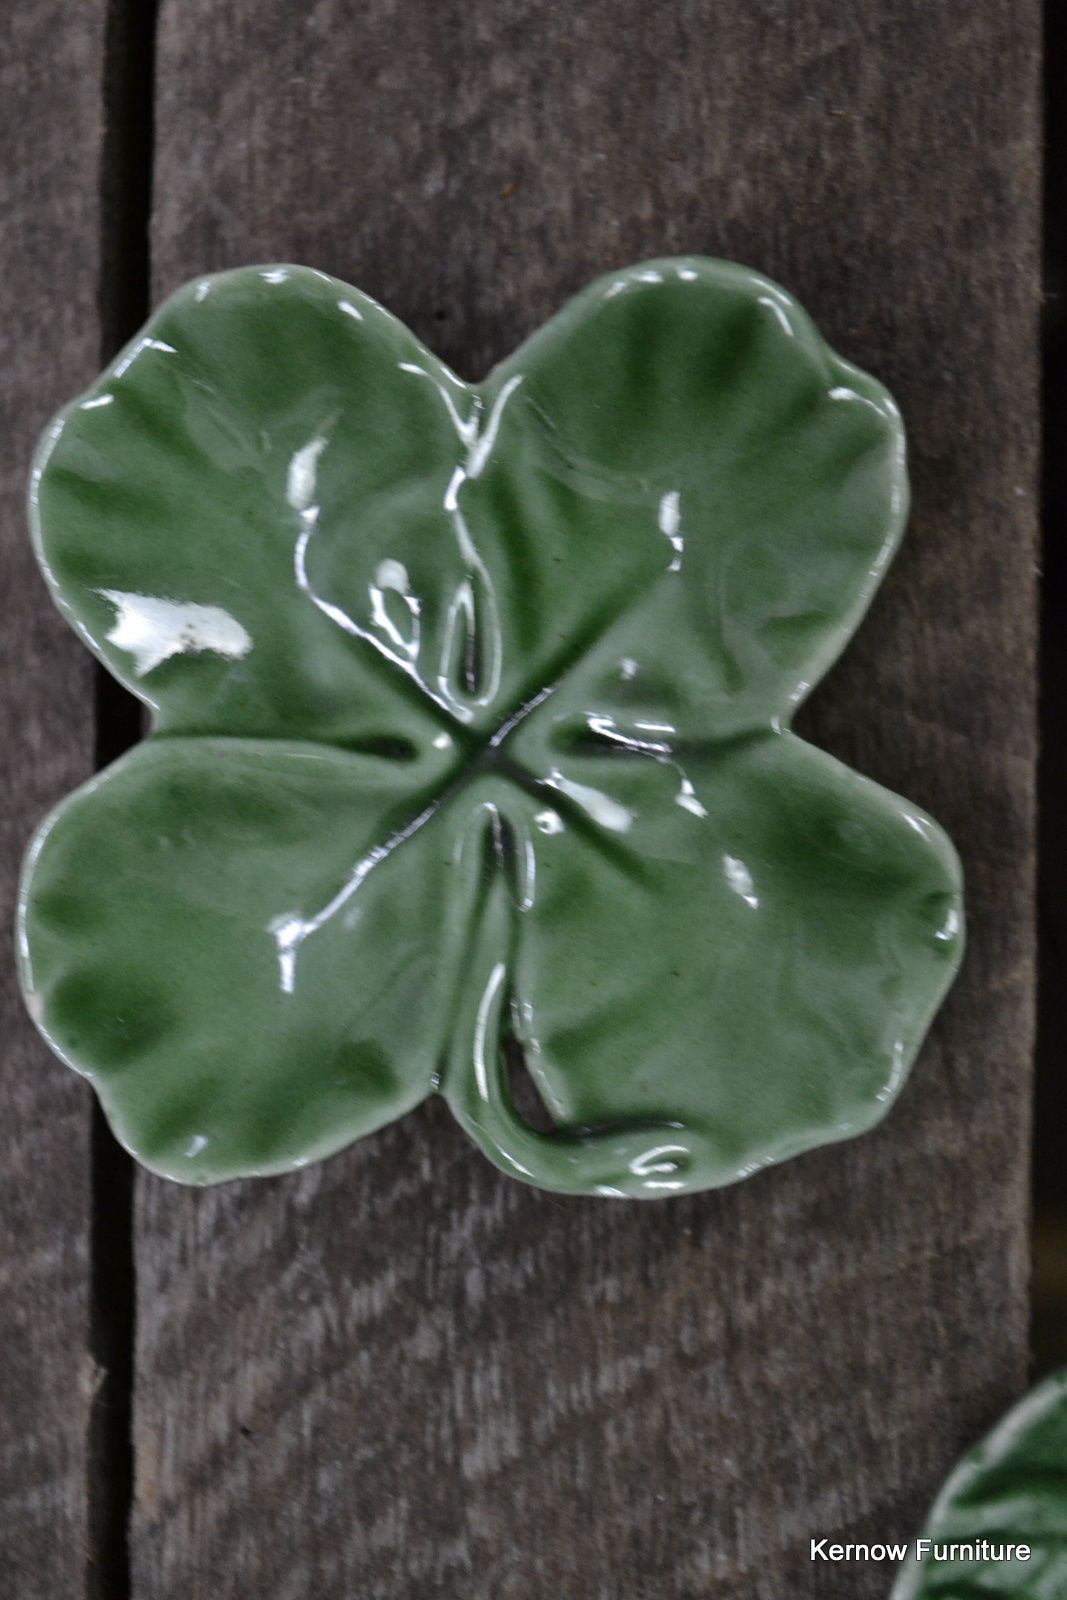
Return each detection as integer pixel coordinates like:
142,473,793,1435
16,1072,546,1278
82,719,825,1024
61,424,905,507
19,258,961,1198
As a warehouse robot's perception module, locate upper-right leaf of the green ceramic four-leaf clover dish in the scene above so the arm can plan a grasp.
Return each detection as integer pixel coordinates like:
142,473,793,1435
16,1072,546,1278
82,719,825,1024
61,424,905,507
478,261,907,733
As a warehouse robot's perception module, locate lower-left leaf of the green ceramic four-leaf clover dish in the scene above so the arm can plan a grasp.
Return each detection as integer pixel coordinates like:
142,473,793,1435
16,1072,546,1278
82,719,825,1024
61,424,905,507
21,738,467,1182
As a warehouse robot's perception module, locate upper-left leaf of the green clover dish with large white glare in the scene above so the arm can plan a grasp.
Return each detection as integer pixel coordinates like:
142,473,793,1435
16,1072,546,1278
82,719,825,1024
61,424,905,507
32,267,489,747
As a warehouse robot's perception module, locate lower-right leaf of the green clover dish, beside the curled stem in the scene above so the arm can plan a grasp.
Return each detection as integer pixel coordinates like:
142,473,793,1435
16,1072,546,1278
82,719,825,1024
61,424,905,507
446,731,960,1194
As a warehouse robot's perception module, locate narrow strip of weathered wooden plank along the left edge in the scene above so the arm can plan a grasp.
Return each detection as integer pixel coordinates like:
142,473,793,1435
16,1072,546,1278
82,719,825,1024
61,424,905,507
0,0,104,1600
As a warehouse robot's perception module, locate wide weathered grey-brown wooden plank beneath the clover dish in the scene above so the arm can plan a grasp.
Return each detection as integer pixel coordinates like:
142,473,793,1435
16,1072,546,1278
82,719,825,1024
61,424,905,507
133,0,1037,1600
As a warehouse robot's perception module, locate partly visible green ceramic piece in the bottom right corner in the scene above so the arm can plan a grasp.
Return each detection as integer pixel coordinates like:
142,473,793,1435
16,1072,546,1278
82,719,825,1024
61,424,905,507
891,1371,1067,1600
